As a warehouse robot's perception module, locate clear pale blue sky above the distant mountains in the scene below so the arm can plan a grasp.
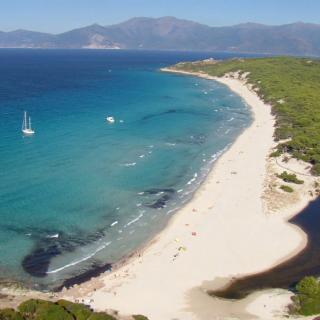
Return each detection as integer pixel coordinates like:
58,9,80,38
0,0,320,33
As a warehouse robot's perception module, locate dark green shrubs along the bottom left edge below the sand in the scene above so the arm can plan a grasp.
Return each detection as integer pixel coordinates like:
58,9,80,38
0,299,148,320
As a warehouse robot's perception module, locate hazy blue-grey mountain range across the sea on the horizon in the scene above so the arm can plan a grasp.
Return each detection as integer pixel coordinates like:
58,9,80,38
0,17,320,55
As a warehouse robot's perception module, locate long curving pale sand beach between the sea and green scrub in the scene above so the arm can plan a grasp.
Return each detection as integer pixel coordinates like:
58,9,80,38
62,69,320,320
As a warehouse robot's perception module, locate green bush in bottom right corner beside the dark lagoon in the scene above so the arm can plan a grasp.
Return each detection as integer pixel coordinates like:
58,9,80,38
292,277,320,316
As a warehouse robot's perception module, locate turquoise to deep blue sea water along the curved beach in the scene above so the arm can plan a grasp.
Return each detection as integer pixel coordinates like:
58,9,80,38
0,50,251,289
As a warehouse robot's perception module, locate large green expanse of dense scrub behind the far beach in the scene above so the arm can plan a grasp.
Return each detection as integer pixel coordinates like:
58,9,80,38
172,57,320,175
